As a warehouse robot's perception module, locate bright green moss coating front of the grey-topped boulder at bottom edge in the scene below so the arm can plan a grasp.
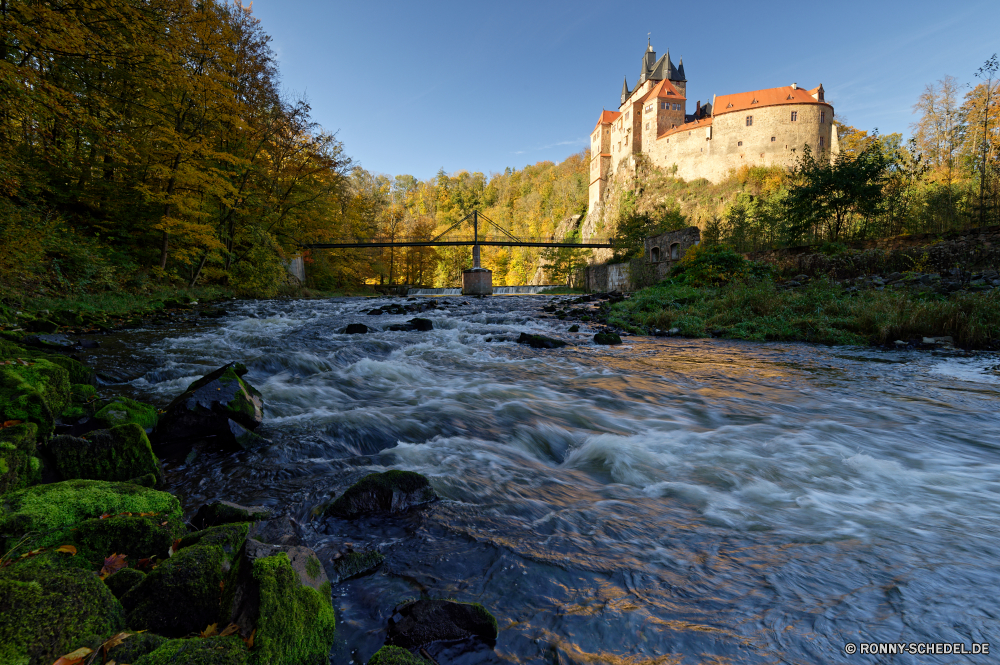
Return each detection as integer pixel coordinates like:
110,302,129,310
251,552,336,665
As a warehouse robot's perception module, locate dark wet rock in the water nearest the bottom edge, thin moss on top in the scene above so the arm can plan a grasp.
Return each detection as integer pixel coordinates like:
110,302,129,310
385,600,499,649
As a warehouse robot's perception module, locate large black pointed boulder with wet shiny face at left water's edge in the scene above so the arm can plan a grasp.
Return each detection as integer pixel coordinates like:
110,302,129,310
154,363,266,457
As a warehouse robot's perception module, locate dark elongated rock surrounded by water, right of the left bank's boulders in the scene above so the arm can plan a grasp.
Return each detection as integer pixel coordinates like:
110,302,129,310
326,469,437,519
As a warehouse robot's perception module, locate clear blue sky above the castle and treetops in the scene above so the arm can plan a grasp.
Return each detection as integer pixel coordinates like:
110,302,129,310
253,0,1000,179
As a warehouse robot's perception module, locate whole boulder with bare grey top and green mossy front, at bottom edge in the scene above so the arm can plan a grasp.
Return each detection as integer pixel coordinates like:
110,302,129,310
220,538,336,665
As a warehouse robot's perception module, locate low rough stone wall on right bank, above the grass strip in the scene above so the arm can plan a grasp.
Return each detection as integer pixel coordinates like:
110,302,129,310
752,226,1000,279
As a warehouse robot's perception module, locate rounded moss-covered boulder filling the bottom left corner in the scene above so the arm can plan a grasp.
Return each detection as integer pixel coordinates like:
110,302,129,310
0,563,125,665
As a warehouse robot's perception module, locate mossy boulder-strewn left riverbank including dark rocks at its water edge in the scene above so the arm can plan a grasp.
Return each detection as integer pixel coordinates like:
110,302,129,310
0,332,497,665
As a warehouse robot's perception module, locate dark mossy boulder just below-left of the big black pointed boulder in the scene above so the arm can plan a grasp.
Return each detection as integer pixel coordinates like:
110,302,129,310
45,423,160,482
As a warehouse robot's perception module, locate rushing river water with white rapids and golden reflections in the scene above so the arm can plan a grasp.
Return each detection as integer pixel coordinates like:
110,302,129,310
76,296,1000,665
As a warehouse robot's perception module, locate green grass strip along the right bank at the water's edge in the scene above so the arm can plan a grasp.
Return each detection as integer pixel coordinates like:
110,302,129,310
608,279,1000,349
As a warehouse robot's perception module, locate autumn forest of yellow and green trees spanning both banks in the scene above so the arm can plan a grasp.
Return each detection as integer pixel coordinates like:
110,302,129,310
0,0,1000,301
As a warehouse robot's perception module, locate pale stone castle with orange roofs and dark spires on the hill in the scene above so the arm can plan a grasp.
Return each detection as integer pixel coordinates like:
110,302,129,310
590,45,839,210
